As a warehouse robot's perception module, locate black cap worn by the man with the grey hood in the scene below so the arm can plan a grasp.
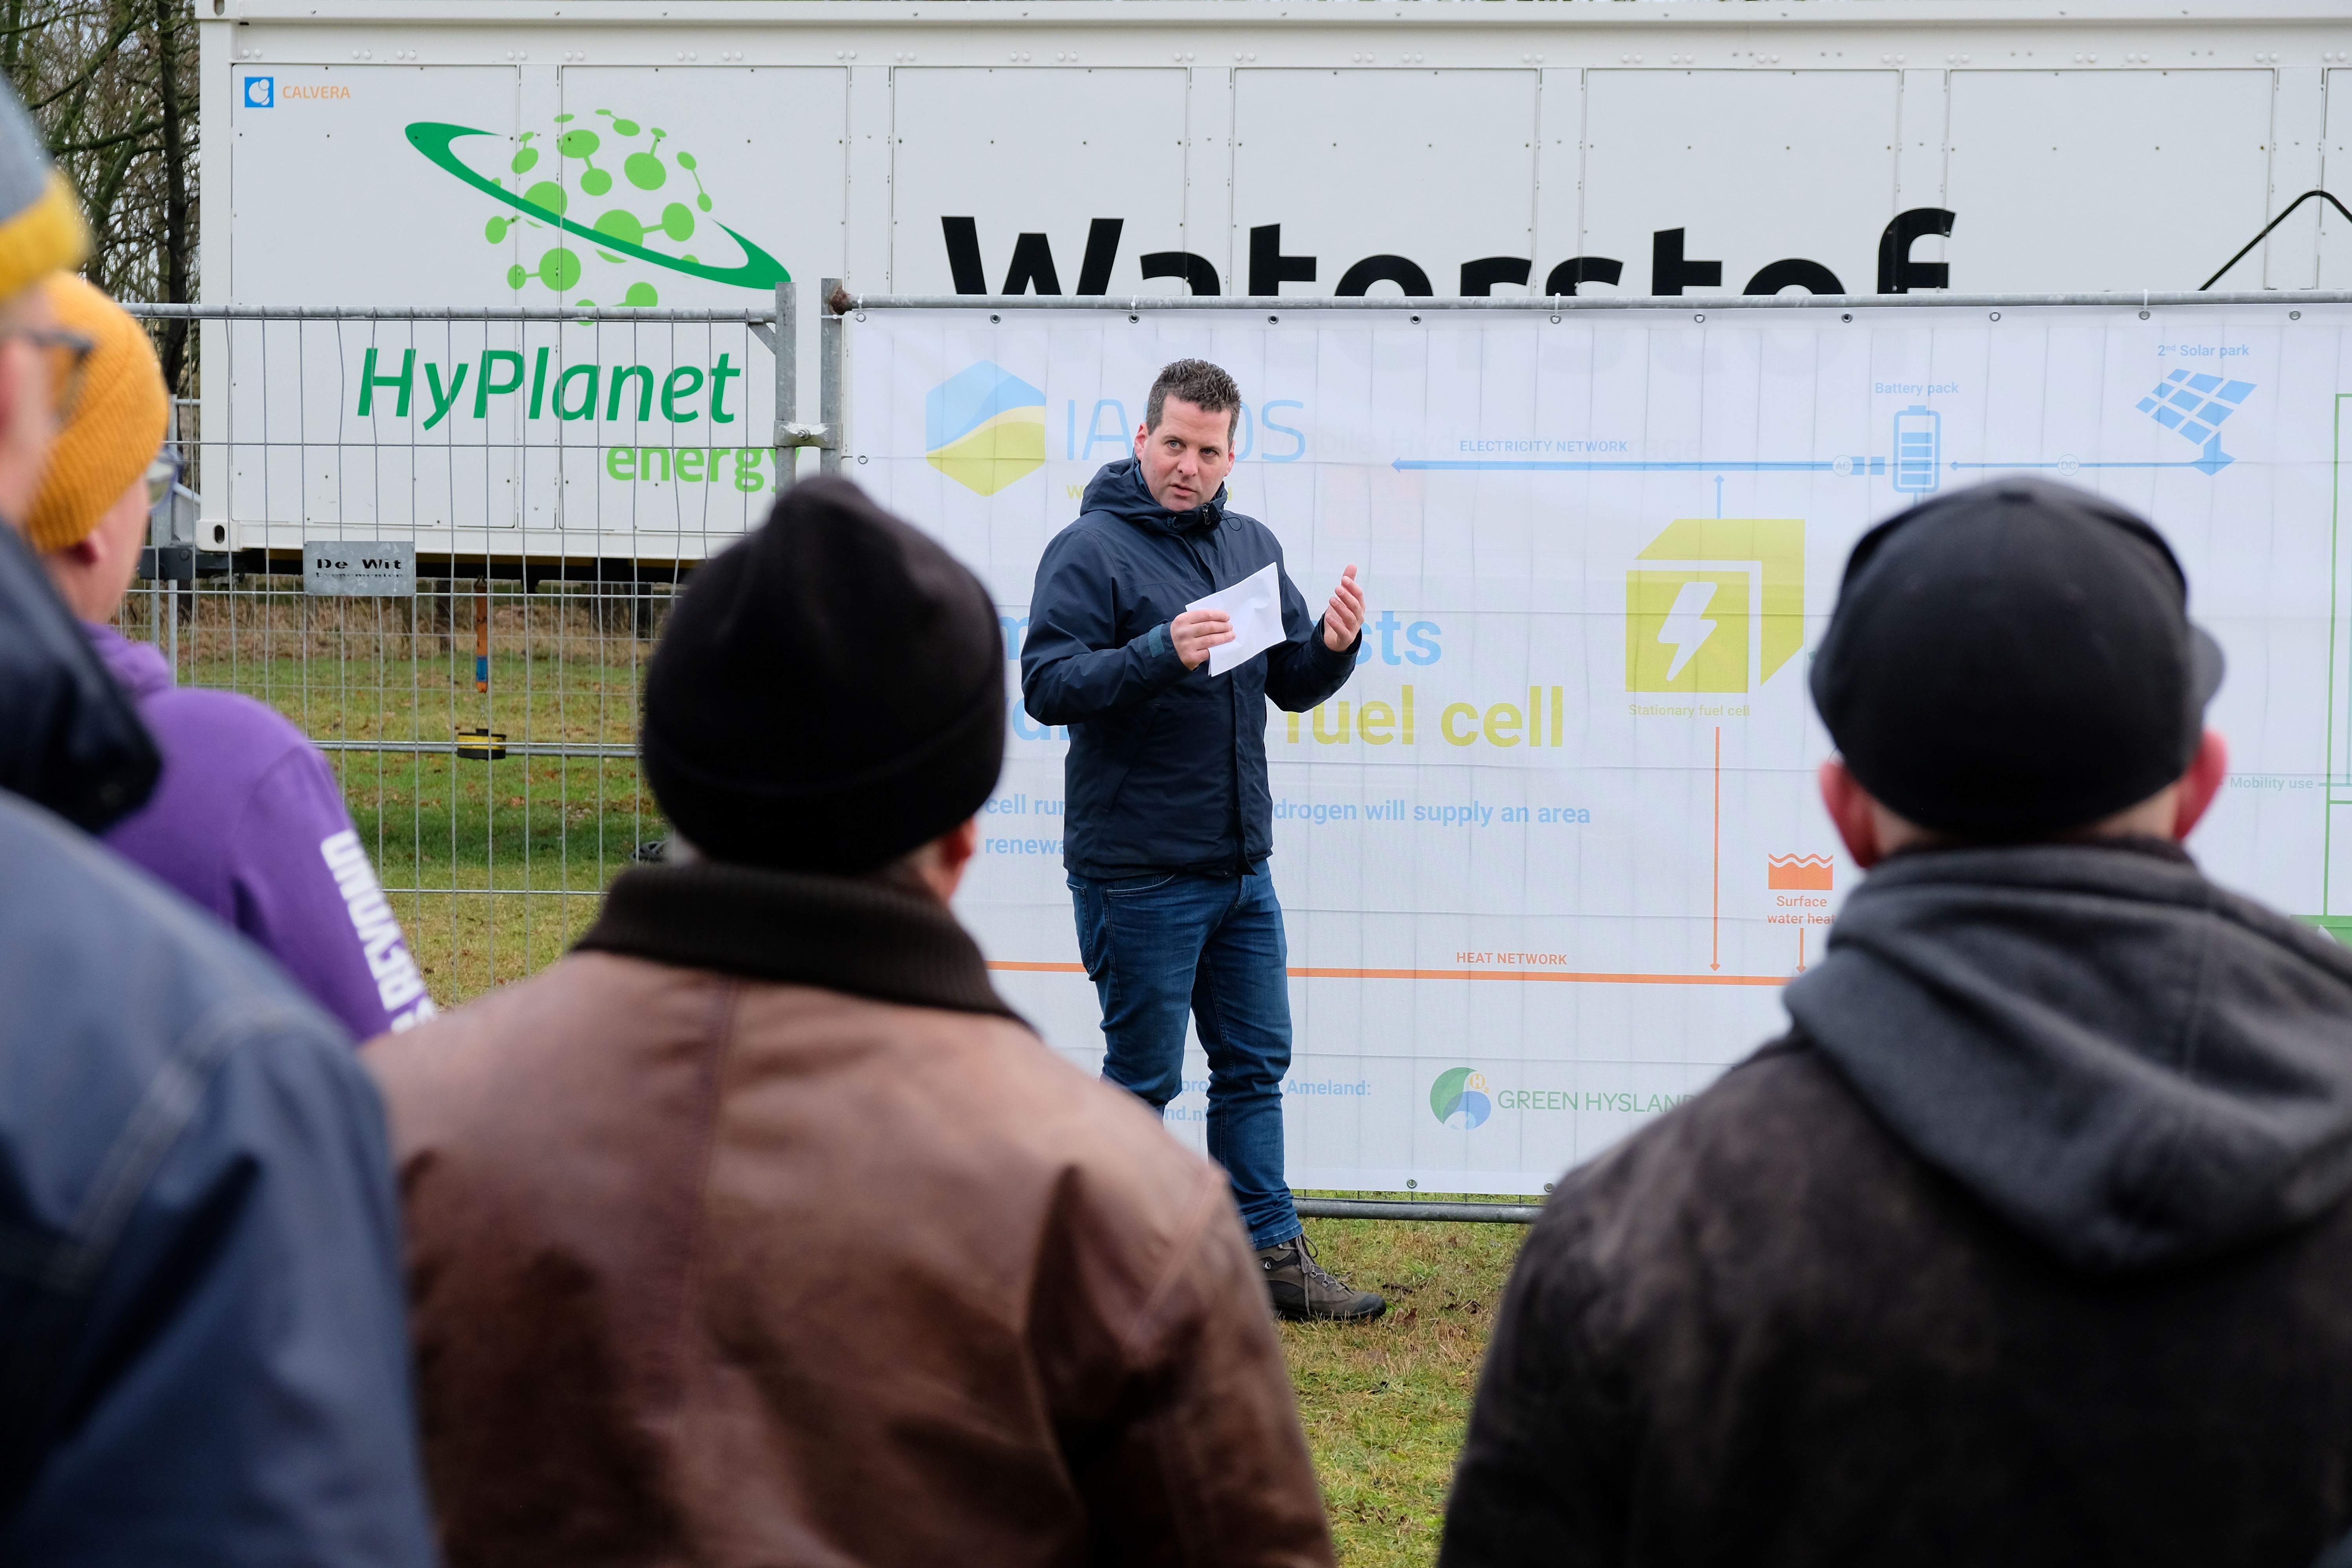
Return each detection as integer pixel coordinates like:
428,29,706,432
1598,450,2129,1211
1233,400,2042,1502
1811,479,2223,842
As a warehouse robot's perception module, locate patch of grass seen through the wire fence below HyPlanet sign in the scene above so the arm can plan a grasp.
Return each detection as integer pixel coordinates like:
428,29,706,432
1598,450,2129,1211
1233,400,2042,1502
122,581,668,1006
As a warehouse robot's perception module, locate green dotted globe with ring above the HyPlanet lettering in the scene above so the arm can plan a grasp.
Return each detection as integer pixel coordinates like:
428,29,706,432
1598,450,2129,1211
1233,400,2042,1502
407,108,790,306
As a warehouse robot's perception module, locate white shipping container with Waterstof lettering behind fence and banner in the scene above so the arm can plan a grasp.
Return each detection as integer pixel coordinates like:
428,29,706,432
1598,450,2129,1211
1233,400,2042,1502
200,0,2352,557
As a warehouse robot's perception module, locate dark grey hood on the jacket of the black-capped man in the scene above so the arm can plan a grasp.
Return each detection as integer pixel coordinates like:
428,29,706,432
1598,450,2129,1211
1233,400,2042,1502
1788,839,2352,1272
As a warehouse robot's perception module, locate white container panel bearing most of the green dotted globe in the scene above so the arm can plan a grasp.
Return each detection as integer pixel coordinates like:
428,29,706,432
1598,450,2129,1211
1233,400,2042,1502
543,66,849,559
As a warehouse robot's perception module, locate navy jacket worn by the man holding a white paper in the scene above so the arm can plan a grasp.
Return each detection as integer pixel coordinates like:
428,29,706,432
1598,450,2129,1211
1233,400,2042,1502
1021,458,1364,877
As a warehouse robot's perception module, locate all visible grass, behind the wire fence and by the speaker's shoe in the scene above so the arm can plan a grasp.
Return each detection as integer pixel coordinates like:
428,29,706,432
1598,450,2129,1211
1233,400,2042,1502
125,590,1526,1568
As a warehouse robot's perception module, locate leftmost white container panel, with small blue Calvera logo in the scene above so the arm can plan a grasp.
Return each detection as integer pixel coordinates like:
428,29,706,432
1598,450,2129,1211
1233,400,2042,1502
228,64,517,548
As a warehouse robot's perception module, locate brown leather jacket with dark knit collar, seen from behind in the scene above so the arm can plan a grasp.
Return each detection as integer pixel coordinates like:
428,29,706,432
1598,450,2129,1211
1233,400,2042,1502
367,865,1331,1568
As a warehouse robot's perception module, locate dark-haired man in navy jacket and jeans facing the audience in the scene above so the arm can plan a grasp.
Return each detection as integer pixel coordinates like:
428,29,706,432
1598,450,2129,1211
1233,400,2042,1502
1021,360,1388,1319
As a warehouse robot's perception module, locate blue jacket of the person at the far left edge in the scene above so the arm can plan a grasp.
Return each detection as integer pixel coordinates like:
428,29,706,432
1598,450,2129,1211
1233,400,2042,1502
0,522,433,1568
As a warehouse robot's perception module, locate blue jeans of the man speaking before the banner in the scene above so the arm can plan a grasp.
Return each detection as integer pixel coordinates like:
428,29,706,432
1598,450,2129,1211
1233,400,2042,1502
1070,863,1298,1246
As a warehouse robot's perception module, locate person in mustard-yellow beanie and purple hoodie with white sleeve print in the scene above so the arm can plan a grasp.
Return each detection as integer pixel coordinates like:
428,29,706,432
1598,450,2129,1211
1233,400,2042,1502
41,275,433,1039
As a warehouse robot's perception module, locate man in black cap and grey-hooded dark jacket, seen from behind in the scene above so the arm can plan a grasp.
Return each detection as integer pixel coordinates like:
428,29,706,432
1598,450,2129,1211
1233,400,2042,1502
1439,479,2352,1568
